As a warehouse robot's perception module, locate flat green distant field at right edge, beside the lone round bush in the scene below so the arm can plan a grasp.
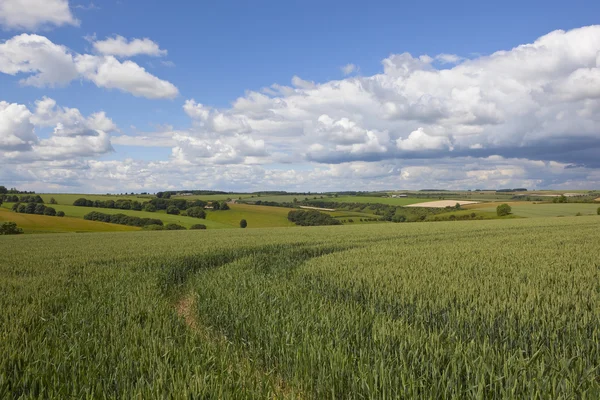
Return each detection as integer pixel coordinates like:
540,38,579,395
477,202,598,218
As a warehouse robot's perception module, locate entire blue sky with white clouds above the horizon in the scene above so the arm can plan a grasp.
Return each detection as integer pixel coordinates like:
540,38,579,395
0,0,600,193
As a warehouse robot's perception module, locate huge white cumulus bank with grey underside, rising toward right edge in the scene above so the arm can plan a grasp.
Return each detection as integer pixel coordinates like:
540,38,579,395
179,26,600,166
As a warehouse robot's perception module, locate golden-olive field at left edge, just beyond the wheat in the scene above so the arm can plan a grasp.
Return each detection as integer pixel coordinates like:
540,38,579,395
0,208,141,233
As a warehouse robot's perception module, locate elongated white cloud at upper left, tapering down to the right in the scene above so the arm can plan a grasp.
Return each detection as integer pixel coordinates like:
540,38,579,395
0,34,179,99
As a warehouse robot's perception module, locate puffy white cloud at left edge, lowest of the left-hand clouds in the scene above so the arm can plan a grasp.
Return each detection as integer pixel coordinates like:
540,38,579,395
0,97,117,164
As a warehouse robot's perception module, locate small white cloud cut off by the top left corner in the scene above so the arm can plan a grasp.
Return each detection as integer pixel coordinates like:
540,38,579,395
0,0,79,30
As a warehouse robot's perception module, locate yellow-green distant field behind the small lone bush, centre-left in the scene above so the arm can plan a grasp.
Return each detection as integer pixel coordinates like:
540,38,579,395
206,204,295,228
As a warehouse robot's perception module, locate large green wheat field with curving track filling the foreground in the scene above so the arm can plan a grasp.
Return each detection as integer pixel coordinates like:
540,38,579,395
0,216,600,399
